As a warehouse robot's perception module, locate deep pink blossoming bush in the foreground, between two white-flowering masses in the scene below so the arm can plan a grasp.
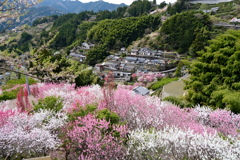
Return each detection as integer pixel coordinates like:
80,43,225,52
67,114,127,160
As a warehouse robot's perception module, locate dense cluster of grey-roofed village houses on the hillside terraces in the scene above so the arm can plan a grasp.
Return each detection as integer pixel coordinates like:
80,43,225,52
94,47,178,81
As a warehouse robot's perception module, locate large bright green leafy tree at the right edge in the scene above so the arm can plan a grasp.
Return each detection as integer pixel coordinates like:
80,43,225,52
186,30,240,113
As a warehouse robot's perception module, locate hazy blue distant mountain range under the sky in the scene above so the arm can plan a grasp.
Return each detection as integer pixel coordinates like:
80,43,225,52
0,0,127,31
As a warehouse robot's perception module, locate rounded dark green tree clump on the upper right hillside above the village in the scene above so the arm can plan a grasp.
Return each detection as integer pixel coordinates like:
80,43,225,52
159,11,211,53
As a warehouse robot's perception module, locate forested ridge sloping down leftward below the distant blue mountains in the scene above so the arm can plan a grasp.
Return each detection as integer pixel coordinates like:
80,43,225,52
2,0,161,51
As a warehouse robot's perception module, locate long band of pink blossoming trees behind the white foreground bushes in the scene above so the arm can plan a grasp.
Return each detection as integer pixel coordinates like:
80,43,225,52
19,84,240,136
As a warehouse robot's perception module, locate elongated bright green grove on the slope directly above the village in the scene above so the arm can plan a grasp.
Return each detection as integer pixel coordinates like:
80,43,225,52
87,16,161,49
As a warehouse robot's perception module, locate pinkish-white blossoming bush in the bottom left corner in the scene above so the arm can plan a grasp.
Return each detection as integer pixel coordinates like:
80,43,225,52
0,110,67,158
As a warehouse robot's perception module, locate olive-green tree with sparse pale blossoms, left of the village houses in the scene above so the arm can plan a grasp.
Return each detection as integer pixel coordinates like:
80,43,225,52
29,49,87,83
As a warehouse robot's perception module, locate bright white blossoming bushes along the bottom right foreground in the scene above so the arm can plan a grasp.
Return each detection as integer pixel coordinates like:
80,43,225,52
128,127,240,160
